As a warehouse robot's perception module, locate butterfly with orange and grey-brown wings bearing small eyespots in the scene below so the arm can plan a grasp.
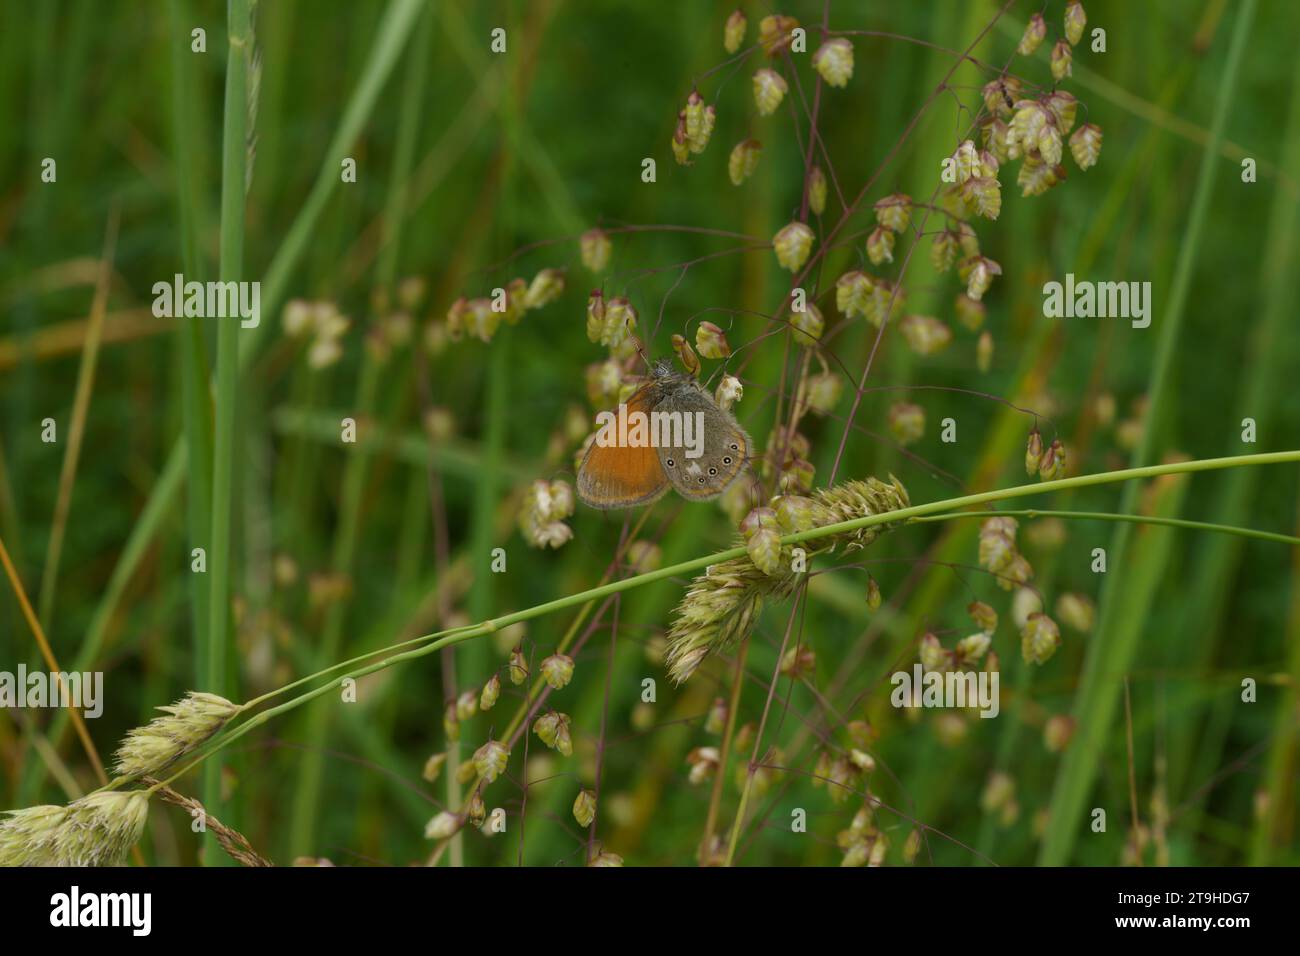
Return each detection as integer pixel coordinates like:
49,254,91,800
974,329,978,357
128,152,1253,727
577,360,753,510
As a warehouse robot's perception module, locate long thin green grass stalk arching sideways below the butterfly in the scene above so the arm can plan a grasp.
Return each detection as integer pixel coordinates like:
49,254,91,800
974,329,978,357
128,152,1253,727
107,450,1300,801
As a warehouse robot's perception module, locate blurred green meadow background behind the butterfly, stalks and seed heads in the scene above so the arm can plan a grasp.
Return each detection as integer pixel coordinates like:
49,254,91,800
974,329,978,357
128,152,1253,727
0,0,1300,865
